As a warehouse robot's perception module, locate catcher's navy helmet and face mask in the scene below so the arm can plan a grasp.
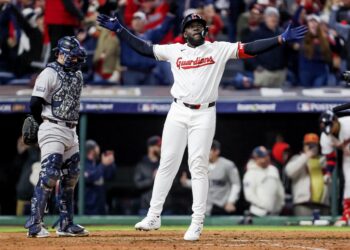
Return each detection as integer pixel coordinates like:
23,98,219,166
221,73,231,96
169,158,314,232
53,36,87,70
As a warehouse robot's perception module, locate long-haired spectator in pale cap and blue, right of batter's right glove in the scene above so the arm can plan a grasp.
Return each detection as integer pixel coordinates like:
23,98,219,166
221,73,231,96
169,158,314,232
299,14,332,87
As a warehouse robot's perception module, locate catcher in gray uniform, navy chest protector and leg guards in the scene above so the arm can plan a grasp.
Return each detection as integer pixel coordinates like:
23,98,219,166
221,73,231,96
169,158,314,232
23,36,88,237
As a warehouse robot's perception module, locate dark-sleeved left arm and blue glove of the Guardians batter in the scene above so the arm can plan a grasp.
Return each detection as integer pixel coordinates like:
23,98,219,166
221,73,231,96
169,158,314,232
97,14,155,58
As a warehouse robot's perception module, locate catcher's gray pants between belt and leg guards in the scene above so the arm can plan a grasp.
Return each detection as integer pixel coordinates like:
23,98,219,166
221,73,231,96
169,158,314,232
38,121,79,162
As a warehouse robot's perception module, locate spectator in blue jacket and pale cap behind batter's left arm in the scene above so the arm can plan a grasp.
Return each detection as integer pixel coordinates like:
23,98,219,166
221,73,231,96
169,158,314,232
120,11,174,85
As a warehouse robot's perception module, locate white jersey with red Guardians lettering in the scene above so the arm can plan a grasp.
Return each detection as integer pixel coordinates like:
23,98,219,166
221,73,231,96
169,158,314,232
153,42,238,104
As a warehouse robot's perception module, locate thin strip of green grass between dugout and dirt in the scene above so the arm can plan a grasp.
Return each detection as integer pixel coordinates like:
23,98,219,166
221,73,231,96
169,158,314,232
0,225,350,233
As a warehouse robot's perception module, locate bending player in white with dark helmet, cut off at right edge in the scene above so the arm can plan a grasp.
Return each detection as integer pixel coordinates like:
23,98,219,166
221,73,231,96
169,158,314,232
320,110,350,226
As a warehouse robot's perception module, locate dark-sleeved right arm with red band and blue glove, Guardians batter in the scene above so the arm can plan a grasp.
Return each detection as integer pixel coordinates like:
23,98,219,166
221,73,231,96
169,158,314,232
239,24,308,58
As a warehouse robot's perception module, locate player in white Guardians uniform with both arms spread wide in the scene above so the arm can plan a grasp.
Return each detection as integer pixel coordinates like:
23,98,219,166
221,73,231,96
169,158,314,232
97,14,307,241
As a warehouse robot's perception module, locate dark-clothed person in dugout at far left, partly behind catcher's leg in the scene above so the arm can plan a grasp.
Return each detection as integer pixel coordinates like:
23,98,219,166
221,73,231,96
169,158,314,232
13,137,40,216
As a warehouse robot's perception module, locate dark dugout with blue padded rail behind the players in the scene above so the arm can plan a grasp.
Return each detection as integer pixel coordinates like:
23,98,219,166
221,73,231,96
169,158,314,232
0,86,350,215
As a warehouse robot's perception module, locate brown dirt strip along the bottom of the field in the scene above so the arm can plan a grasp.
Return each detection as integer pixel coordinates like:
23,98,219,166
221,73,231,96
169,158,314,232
0,230,350,250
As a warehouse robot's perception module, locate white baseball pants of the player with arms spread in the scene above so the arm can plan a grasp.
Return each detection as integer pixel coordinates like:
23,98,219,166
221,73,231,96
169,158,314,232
148,102,216,223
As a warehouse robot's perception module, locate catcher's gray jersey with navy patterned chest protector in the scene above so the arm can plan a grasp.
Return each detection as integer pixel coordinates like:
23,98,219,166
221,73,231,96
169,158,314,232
32,62,83,122
